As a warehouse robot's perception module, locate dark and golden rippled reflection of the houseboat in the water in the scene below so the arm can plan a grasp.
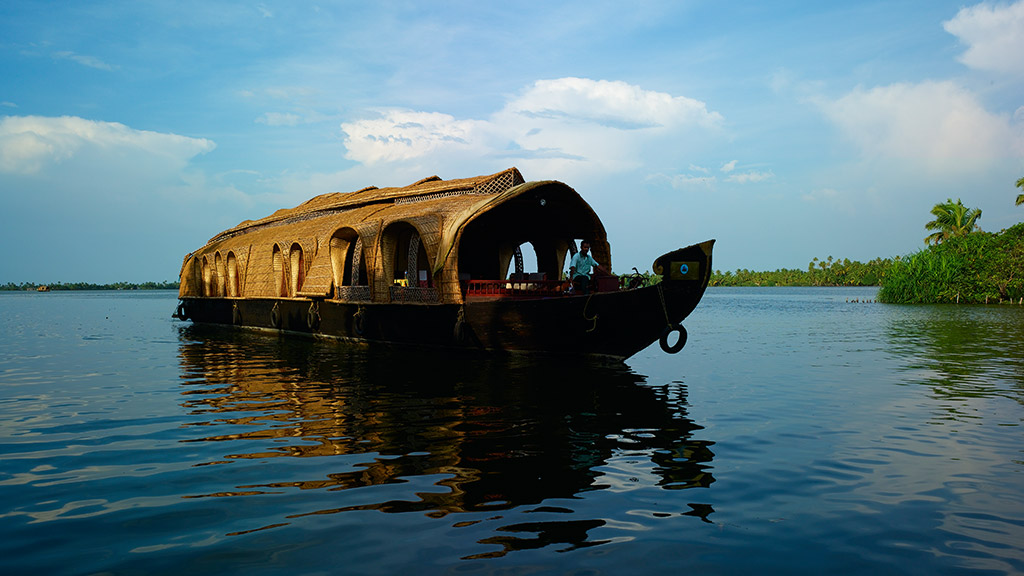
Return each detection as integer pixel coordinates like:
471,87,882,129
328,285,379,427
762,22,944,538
180,327,713,553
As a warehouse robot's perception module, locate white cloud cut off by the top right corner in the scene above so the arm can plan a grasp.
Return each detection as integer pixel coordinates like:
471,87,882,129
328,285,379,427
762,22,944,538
942,1,1024,75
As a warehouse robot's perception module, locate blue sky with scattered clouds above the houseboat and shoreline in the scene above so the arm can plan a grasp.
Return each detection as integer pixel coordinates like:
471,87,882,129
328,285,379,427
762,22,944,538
0,0,1024,283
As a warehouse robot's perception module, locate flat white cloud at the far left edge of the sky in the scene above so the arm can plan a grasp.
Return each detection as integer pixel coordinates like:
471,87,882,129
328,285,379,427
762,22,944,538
0,116,215,174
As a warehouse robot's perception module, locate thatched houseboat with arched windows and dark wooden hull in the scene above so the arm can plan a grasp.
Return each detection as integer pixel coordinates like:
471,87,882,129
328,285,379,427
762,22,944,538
174,168,715,360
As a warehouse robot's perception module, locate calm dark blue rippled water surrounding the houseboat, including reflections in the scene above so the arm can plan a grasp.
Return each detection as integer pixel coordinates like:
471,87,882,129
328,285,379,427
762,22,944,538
0,288,1024,575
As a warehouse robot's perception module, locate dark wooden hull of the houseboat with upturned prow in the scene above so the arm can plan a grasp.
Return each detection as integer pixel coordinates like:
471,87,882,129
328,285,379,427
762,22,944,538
178,238,711,360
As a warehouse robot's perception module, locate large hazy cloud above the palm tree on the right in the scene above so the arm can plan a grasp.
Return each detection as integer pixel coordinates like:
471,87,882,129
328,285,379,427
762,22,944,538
818,82,1024,168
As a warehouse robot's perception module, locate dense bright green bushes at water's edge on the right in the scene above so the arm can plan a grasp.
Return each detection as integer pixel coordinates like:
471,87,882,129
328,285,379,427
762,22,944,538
878,219,1024,303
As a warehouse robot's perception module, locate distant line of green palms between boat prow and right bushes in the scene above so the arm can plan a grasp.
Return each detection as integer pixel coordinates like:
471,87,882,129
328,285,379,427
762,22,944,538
709,256,893,286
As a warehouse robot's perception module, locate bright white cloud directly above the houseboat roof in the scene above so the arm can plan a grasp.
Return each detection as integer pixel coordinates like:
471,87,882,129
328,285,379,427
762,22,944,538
341,78,723,171
